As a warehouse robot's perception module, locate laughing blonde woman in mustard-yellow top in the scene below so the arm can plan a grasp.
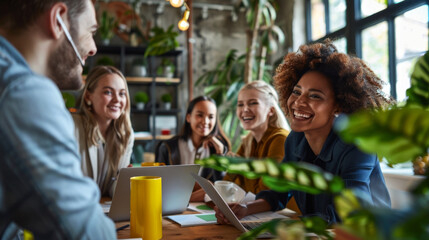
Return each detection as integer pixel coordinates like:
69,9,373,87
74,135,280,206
224,80,289,194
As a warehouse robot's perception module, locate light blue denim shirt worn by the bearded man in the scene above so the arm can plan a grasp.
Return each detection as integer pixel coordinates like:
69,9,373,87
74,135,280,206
0,36,116,239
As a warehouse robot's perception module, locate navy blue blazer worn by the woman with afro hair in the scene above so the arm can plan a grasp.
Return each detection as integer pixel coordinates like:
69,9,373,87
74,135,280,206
256,130,390,224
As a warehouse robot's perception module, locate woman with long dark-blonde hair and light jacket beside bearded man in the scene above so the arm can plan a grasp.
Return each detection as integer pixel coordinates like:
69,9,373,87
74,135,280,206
73,66,134,196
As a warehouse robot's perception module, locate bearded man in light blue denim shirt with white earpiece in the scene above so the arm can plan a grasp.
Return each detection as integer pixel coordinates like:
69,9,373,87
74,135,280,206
0,0,116,239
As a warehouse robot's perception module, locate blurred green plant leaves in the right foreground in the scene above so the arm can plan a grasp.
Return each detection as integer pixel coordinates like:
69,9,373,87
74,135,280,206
197,53,429,240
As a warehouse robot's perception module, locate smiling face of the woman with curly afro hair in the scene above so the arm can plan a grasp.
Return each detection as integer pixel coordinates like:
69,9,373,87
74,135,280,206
287,71,338,136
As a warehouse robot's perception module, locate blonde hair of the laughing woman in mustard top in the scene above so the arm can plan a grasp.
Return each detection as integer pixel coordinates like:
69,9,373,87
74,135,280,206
240,80,290,157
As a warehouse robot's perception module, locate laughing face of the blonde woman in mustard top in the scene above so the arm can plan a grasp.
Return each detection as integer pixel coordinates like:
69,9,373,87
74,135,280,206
236,89,274,133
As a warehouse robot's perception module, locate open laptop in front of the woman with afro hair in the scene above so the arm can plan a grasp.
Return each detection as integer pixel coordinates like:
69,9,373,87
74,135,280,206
192,174,286,238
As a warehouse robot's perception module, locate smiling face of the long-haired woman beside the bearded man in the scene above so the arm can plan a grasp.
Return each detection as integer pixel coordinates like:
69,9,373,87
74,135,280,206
85,74,128,125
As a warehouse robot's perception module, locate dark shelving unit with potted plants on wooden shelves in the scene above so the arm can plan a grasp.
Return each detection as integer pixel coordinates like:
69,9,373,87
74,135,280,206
88,46,183,152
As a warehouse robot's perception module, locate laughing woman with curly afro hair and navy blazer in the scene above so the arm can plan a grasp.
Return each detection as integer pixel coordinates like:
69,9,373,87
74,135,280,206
216,40,391,224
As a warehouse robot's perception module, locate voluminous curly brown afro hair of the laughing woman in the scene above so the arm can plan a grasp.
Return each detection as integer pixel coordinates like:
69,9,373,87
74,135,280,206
274,39,392,115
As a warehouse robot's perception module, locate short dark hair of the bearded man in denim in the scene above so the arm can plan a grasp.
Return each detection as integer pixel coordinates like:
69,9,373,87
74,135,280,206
0,0,89,33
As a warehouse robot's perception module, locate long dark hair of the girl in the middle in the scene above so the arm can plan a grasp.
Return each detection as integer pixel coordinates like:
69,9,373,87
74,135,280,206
178,96,231,150
